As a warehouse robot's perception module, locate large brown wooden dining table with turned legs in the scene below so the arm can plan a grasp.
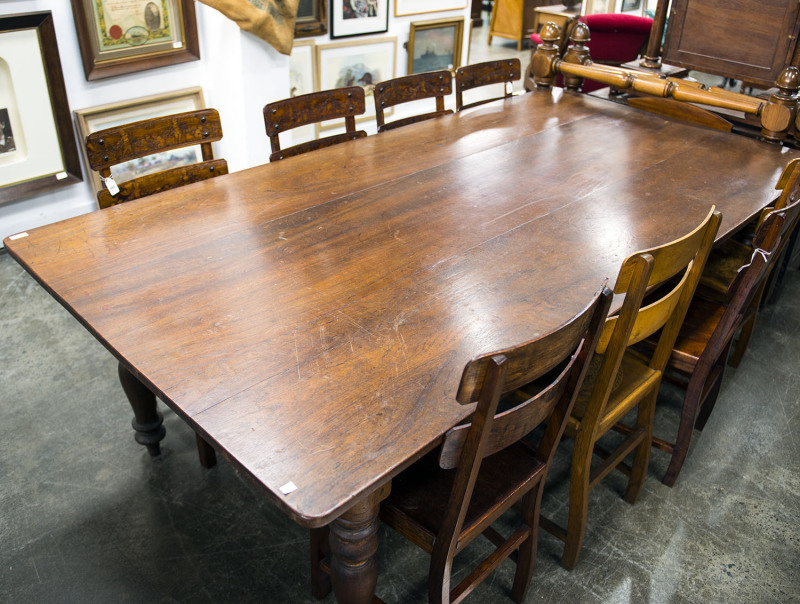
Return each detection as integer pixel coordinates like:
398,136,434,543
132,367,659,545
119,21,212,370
5,88,798,602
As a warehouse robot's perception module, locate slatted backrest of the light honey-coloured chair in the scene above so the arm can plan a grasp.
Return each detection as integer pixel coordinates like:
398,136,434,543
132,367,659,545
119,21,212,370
587,207,722,417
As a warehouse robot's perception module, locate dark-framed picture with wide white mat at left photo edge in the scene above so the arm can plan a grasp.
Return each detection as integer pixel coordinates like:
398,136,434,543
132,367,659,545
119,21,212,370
0,11,82,203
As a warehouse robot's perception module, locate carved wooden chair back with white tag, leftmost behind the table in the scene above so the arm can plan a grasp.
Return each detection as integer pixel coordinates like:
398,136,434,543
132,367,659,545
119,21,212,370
86,109,228,208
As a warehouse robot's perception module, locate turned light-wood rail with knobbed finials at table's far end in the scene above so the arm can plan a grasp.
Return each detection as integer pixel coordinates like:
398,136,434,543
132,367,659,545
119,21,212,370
531,22,800,143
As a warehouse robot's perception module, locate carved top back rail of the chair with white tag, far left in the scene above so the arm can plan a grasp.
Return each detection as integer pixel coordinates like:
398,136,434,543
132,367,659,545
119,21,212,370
86,109,222,172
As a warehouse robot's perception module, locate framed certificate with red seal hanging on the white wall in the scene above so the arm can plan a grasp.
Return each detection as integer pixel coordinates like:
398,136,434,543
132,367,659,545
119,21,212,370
72,0,200,80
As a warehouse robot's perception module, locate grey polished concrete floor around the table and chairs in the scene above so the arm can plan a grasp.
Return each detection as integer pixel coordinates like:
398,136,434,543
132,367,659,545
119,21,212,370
0,253,800,604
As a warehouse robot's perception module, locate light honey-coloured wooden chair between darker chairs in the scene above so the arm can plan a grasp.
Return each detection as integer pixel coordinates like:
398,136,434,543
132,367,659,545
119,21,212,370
541,208,721,569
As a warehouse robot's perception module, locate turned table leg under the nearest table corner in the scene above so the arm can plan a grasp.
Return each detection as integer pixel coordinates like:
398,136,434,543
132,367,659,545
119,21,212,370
330,483,391,604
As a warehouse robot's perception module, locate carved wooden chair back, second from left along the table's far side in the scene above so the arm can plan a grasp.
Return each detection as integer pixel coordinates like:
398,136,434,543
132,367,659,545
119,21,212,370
264,86,367,162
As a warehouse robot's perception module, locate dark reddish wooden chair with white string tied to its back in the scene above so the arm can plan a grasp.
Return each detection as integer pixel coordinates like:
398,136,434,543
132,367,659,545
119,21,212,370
642,210,786,487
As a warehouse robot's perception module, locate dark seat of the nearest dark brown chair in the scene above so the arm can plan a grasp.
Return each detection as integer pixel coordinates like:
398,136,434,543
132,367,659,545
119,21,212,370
381,442,545,552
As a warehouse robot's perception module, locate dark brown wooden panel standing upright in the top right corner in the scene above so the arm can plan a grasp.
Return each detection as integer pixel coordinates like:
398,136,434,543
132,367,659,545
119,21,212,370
660,0,800,88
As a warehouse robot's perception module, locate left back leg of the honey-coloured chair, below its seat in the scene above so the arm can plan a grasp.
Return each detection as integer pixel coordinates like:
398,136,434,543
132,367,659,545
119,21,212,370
561,434,594,570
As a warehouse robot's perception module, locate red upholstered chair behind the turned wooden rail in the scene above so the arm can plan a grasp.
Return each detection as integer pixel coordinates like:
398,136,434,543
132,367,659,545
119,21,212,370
531,13,653,92
